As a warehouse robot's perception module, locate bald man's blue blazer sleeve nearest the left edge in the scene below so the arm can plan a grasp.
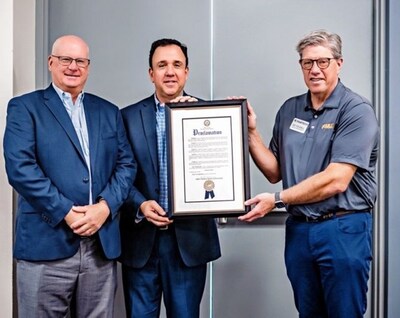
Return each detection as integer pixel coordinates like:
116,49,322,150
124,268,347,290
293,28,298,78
3,98,73,227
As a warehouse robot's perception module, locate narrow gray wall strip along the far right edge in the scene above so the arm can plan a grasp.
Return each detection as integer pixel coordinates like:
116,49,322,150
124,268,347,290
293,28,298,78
385,0,400,317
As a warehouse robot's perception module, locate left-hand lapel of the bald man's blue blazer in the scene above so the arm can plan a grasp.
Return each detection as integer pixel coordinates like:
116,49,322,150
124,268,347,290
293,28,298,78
44,85,85,161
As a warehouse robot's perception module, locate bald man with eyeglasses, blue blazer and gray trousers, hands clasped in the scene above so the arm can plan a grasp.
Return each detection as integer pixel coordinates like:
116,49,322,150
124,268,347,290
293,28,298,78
4,35,136,318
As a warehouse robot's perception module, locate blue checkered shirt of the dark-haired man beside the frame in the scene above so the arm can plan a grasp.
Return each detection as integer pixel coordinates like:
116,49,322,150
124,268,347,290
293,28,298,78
156,103,168,212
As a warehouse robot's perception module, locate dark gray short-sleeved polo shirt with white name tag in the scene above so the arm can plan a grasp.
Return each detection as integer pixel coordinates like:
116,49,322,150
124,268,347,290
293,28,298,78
270,81,379,216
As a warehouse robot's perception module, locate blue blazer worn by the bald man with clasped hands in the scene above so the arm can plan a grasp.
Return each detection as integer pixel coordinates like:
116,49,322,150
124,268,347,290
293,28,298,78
4,85,136,261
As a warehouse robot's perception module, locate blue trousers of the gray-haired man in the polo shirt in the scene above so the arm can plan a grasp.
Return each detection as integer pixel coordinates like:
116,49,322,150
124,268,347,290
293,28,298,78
285,212,372,318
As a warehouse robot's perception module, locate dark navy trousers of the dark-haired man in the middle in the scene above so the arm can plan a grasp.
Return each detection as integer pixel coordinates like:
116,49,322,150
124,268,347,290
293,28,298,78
122,228,207,318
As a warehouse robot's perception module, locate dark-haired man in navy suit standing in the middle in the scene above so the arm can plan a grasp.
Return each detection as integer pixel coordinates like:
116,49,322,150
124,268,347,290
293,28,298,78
120,39,221,318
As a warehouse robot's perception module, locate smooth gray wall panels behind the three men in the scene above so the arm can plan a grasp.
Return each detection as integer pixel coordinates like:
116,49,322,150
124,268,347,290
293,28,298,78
38,0,382,318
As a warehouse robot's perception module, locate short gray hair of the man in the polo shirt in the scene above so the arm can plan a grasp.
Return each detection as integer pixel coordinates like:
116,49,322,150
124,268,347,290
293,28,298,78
296,30,342,59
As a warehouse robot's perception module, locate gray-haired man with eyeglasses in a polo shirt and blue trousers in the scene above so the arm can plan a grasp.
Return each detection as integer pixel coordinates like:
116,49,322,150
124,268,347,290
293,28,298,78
239,30,379,318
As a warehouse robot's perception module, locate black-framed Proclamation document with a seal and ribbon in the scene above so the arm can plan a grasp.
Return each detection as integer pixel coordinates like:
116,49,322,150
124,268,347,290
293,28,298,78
166,99,250,217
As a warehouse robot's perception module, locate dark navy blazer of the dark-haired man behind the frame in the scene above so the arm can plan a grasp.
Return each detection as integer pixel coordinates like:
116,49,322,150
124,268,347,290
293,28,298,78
120,95,221,268
